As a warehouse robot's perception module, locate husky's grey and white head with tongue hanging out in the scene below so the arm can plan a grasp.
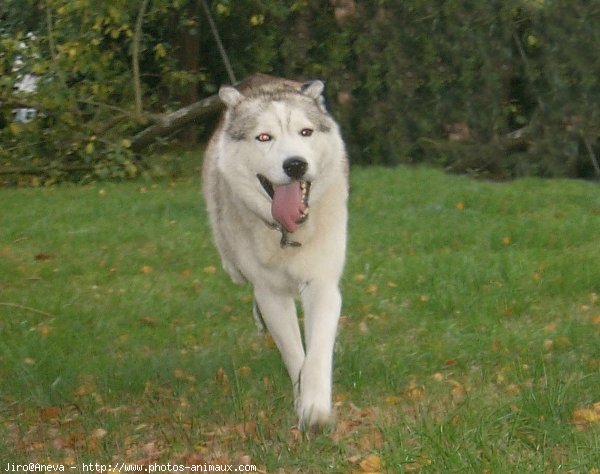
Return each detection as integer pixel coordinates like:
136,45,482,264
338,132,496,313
219,81,345,232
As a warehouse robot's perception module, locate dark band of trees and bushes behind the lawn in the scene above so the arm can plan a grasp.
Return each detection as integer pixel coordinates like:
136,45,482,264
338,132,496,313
0,0,600,184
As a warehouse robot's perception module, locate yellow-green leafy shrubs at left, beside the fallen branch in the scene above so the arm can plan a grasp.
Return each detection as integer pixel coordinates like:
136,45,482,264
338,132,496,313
0,0,202,182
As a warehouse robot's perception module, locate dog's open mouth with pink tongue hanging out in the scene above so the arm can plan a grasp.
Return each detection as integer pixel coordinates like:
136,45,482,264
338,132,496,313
256,174,310,232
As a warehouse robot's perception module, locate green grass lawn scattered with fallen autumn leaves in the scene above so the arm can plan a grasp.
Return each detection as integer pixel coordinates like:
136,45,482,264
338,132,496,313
0,168,600,473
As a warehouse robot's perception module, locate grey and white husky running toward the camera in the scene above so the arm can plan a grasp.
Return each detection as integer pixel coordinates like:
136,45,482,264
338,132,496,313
203,76,348,429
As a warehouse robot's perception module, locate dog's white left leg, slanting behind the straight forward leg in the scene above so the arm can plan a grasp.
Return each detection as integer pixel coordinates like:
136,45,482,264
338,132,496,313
254,287,304,387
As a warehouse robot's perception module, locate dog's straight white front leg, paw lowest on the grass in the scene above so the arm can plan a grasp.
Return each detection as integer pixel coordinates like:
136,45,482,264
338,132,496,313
296,281,342,429
